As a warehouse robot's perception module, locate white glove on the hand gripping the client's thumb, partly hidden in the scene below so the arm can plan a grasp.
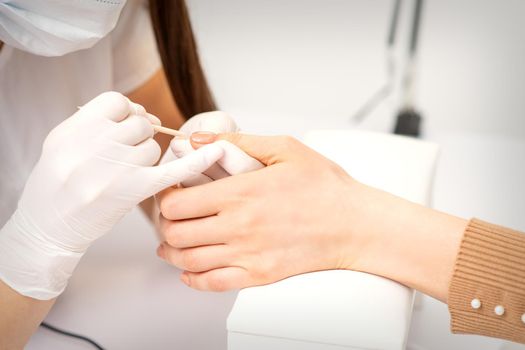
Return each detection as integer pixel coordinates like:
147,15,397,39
161,111,264,187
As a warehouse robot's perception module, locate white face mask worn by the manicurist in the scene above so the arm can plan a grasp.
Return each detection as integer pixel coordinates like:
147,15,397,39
0,0,126,56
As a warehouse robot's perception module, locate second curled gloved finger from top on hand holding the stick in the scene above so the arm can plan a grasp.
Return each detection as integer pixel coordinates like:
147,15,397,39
107,115,154,146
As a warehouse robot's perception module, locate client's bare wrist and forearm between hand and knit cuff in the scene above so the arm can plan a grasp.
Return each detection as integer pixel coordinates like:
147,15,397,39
340,184,467,301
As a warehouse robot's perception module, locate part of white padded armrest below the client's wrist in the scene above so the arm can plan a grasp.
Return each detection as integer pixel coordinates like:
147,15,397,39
228,270,413,350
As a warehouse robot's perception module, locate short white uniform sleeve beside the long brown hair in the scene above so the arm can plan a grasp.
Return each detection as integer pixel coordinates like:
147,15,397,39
110,0,162,94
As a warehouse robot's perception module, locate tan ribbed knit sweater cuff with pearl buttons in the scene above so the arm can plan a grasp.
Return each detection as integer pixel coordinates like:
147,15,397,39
448,219,525,343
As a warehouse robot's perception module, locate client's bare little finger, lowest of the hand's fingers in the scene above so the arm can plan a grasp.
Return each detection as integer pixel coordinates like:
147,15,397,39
181,267,250,292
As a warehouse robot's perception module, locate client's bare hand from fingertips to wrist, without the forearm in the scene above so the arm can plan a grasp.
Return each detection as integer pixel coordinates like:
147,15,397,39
158,134,365,291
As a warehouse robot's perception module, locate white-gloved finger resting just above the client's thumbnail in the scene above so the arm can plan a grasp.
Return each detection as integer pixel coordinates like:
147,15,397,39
180,111,239,136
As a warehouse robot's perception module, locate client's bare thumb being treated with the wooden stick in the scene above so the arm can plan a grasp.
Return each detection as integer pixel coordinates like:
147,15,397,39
190,132,300,165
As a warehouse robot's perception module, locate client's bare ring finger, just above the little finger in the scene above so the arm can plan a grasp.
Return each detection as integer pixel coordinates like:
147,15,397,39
157,243,234,272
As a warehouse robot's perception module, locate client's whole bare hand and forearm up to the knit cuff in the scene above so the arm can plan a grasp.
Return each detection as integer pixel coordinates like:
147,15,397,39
158,134,466,300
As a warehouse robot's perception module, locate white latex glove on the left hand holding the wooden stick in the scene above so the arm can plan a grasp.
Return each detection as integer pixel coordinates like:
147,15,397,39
0,92,223,299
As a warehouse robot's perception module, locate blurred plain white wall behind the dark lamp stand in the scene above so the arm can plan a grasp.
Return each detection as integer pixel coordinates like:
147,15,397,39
184,0,525,138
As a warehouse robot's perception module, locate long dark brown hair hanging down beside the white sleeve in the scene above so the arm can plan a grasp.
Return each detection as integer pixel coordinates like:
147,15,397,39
149,0,217,119
